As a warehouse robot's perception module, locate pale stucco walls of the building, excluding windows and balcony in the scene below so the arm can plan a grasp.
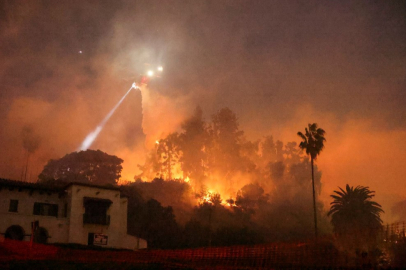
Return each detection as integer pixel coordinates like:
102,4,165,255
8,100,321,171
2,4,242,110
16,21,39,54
0,184,147,249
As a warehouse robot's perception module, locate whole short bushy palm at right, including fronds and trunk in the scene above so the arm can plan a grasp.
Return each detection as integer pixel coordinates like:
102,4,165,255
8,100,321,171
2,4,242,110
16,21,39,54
327,184,384,250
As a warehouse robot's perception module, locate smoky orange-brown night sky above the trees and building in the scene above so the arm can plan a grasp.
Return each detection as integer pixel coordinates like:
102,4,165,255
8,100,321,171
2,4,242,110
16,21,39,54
0,0,406,220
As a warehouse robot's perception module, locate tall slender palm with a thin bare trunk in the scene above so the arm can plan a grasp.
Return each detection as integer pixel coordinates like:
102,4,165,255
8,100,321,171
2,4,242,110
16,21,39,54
297,123,326,238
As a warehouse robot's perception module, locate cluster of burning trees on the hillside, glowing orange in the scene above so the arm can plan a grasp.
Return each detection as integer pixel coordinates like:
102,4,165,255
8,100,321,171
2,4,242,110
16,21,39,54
136,108,329,246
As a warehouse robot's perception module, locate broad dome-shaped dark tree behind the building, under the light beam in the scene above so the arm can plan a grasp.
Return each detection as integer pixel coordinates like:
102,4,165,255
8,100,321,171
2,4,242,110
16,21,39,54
38,150,123,184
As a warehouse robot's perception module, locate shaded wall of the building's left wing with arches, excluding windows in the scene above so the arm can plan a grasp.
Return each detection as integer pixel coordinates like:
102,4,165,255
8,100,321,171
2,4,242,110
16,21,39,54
0,187,69,243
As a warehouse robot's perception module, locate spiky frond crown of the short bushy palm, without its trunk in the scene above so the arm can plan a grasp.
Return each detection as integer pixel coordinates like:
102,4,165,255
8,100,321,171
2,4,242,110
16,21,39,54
327,184,383,234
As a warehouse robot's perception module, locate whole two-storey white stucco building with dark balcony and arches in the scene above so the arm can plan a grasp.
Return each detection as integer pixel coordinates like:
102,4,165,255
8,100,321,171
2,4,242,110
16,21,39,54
0,179,147,249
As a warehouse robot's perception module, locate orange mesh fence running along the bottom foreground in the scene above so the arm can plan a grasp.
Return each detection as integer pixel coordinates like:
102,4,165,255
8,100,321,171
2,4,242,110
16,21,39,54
0,240,346,269
